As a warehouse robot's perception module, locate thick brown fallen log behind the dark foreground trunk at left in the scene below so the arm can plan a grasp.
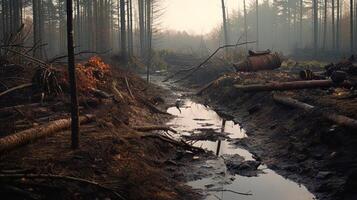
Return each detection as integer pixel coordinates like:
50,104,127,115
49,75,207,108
0,115,94,152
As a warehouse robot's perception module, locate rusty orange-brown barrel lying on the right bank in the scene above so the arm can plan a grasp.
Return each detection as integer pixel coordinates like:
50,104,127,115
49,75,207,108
234,53,281,72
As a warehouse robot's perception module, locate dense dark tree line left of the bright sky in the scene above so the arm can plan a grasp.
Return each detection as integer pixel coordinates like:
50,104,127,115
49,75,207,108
0,0,157,61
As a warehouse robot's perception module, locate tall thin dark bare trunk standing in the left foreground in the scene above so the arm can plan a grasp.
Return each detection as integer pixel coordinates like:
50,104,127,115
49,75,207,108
67,0,79,149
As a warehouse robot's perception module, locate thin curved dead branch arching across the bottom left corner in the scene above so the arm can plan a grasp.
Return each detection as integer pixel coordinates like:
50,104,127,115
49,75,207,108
0,174,125,200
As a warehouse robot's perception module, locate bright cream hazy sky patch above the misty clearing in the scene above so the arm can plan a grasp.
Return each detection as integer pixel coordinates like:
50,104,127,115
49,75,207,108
161,0,245,34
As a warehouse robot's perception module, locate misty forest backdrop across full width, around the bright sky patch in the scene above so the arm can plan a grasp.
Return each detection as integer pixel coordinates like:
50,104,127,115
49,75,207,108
0,0,357,59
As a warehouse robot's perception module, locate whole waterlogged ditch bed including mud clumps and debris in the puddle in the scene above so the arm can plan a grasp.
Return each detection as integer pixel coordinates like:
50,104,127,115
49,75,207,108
167,98,315,200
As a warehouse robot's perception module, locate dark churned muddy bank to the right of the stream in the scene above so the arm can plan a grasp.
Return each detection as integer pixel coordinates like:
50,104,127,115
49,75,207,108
163,53,357,200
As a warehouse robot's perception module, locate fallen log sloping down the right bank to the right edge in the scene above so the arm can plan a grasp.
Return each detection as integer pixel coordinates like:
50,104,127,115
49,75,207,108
273,95,357,129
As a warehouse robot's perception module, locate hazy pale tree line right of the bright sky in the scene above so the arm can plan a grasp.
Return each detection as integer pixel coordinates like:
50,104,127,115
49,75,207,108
218,0,357,54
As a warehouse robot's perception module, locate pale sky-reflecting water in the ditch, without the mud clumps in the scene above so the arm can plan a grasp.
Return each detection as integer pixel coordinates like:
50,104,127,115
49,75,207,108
168,100,314,200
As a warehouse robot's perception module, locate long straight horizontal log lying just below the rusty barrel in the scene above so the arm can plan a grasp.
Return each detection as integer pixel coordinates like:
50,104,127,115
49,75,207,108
234,80,357,92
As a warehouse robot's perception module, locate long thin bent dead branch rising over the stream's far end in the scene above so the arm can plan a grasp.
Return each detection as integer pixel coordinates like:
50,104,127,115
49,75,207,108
164,41,255,83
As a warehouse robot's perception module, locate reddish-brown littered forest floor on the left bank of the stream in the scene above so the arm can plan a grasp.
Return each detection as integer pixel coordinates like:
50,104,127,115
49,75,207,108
0,56,210,199
